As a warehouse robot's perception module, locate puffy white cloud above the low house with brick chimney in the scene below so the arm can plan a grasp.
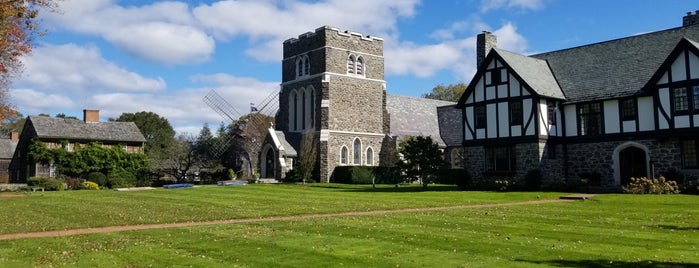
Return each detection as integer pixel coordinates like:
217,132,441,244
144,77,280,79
15,44,166,91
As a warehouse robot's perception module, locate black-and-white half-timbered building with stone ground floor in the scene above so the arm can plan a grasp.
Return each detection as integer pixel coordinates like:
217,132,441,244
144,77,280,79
457,13,699,190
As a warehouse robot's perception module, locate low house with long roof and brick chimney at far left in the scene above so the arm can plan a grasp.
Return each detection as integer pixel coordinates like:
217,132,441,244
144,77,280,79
9,110,146,183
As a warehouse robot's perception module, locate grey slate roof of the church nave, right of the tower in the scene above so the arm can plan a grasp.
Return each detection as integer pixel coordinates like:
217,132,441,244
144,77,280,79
386,94,455,147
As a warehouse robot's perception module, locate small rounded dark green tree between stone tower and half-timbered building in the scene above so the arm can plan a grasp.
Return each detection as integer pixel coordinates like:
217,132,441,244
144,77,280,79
397,136,447,188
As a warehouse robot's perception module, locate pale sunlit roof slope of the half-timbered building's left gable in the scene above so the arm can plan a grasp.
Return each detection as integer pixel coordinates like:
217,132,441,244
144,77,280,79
493,48,565,99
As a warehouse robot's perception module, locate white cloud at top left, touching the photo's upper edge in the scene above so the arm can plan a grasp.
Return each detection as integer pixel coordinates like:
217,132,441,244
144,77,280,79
47,0,215,65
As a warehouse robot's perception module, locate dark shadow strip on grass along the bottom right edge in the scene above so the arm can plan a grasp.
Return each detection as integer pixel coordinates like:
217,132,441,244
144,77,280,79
518,259,699,268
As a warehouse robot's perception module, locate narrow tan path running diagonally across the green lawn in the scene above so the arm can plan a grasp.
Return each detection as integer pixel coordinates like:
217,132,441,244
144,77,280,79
0,199,574,241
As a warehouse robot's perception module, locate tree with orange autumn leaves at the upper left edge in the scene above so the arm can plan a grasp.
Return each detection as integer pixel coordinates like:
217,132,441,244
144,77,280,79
0,0,60,124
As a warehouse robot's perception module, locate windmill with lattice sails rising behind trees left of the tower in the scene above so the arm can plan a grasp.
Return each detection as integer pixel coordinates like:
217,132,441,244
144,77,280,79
203,89,279,177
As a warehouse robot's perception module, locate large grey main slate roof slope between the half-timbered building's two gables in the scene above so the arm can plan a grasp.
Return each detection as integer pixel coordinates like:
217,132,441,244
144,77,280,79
527,24,699,103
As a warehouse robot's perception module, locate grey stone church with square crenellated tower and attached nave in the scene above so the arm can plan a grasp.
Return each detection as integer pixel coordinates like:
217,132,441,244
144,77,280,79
259,26,462,182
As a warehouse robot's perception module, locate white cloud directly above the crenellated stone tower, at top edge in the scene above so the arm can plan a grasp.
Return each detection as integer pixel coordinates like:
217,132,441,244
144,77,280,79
192,0,419,61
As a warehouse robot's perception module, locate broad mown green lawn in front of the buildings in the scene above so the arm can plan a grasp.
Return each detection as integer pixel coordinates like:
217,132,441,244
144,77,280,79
0,185,699,267
